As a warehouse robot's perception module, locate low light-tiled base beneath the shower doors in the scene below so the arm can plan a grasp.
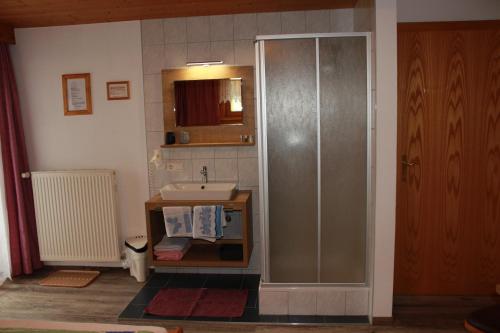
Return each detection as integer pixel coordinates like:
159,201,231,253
259,287,369,316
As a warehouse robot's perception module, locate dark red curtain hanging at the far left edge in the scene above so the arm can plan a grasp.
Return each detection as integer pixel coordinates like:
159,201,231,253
0,44,42,276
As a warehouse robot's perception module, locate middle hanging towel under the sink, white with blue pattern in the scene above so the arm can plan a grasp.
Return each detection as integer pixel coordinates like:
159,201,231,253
193,206,225,242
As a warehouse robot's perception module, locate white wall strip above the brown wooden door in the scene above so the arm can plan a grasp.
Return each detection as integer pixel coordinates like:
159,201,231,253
397,0,500,22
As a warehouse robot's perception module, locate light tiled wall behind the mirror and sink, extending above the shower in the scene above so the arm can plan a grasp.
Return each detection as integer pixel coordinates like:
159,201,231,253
141,9,353,273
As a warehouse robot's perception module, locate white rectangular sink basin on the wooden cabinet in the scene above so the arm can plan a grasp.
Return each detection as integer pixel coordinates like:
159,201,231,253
160,183,236,200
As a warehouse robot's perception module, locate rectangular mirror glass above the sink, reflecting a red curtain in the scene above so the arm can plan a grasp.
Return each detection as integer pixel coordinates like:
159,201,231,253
174,77,243,127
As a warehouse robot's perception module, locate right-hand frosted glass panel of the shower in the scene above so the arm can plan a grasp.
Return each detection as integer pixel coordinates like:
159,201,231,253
319,37,367,283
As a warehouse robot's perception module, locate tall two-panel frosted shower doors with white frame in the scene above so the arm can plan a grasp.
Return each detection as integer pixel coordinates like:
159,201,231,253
256,33,371,285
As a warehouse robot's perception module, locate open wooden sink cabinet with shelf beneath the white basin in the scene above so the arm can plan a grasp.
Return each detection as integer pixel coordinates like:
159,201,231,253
145,191,253,268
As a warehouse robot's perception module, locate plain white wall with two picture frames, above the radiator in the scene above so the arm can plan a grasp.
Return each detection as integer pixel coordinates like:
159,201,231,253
12,21,149,252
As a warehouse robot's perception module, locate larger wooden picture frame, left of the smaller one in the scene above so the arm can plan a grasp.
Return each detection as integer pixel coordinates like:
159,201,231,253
62,73,92,116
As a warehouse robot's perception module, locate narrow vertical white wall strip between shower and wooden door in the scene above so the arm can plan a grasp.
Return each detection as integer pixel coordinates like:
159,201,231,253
373,0,397,317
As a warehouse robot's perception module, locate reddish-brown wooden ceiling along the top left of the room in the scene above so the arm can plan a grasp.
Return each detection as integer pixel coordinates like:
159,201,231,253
0,0,356,28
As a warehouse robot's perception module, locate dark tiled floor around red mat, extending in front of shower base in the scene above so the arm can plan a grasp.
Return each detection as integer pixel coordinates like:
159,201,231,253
120,273,368,324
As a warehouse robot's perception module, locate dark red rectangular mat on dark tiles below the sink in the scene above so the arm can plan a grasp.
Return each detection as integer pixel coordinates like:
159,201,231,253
144,288,248,317
